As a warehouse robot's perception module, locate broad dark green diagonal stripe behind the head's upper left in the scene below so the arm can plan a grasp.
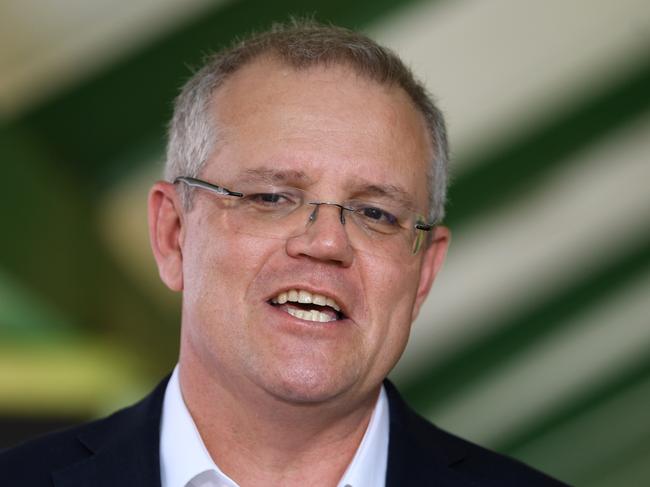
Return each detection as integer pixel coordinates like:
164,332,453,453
7,0,430,187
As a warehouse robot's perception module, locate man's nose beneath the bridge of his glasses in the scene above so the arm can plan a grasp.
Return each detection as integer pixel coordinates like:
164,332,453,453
287,203,354,267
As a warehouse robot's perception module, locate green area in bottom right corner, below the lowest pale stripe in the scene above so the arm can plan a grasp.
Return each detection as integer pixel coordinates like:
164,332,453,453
504,357,650,486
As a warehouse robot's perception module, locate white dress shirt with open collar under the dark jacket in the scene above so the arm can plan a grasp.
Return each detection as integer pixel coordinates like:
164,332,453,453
160,366,389,487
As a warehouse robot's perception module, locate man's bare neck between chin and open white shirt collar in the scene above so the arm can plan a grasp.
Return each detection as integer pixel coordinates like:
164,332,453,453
180,354,379,486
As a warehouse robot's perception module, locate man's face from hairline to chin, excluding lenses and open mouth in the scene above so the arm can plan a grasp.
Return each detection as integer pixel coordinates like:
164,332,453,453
170,60,447,402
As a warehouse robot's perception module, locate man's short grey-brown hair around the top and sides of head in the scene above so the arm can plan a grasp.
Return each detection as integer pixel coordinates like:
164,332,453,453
165,20,449,222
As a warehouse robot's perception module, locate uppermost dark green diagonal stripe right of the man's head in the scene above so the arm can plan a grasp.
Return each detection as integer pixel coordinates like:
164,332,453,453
448,61,650,228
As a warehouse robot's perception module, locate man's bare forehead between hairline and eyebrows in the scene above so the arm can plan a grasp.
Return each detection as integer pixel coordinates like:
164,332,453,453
206,59,432,210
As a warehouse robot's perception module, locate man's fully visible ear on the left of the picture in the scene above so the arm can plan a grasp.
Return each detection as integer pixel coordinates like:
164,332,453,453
147,181,184,291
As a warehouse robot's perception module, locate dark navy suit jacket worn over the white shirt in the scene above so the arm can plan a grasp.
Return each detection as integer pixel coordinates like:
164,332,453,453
0,380,564,487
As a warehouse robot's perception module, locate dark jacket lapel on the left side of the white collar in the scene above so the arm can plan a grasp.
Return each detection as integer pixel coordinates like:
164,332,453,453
52,379,168,487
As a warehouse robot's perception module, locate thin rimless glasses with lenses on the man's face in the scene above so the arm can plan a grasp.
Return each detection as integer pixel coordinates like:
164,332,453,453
174,176,435,257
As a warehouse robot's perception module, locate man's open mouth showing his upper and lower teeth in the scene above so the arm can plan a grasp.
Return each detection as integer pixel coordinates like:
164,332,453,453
269,289,346,323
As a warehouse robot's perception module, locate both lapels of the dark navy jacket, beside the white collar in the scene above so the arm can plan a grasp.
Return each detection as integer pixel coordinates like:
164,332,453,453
52,377,472,487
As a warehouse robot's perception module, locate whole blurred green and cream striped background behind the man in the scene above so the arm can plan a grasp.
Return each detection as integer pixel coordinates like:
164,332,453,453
0,0,650,486
